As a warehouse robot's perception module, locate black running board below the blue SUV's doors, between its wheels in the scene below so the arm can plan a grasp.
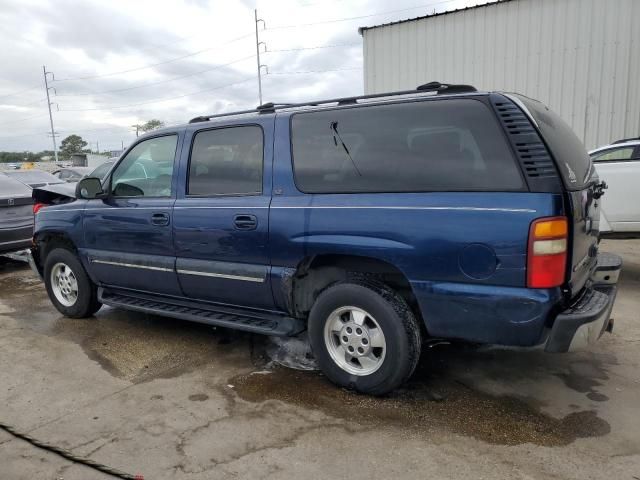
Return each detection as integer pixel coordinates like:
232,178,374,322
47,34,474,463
98,288,306,337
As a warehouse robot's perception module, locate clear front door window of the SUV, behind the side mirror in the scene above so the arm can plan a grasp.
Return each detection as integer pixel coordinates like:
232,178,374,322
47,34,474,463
111,135,178,197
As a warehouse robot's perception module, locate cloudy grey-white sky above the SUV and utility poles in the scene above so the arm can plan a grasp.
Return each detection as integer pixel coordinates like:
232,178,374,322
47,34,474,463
0,0,487,151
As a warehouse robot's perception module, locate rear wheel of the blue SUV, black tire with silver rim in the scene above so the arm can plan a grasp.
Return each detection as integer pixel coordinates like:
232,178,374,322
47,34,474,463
309,281,421,395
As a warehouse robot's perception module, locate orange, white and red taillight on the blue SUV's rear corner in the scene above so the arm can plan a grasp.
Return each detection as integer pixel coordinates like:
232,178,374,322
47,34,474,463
527,217,569,288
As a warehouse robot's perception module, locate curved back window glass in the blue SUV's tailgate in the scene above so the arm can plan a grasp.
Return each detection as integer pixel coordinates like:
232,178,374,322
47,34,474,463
515,95,593,190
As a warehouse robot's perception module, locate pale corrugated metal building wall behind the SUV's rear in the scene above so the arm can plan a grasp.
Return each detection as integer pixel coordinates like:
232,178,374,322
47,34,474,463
363,0,640,149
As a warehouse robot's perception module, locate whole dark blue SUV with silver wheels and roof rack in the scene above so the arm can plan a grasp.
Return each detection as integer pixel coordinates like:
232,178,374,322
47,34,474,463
32,82,621,394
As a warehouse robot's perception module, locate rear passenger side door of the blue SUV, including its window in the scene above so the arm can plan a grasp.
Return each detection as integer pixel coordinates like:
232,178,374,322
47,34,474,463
174,118,273,309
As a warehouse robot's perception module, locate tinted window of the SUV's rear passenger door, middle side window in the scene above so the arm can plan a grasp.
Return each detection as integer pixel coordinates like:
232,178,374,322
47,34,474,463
187,125,264,196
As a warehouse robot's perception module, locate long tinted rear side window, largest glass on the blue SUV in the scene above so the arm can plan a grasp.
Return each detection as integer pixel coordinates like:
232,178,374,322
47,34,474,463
291,99,524,193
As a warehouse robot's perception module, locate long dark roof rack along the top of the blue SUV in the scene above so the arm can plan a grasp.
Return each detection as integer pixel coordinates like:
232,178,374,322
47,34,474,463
189,82,477,123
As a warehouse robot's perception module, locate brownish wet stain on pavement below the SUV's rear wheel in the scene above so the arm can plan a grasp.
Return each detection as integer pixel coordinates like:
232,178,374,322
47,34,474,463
230,368,610,446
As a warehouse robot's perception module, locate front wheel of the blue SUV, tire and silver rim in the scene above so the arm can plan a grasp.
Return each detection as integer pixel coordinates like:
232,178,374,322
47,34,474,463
44,248,102,318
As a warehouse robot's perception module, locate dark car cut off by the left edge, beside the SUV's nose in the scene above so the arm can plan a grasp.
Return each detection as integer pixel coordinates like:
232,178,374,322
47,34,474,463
0,174,33,254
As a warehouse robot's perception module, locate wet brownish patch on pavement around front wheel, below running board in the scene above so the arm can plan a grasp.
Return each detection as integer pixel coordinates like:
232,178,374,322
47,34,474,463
0,270,260,383
